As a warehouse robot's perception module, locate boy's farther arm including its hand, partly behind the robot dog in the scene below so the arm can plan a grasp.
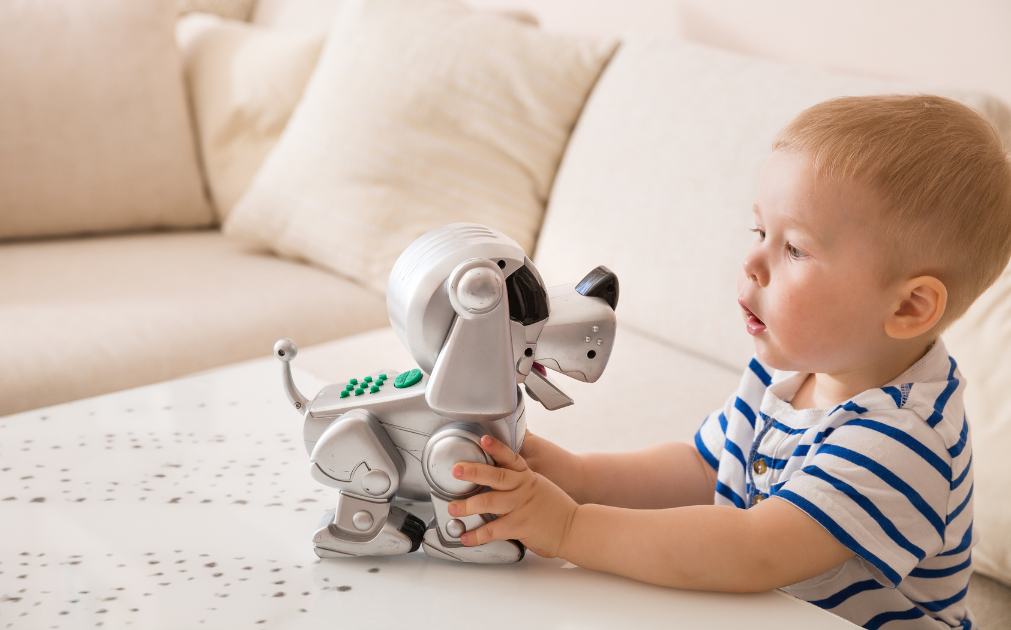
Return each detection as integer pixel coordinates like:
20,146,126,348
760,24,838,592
521,431,716,509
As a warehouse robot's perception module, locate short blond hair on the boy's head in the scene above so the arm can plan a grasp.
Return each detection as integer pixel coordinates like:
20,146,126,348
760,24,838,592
773,94,1011,331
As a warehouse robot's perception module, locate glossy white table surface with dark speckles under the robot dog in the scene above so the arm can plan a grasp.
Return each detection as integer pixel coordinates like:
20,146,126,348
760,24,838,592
0,359,854,630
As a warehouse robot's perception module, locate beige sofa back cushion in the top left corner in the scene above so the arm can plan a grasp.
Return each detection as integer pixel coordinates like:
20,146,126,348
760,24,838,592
0,0,213,240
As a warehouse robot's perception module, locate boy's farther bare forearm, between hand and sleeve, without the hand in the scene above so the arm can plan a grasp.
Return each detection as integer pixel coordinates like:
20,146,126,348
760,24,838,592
578,442,716,510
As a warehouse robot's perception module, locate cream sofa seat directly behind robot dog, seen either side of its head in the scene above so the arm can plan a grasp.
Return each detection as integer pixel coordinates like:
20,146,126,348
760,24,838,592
295,327,744,452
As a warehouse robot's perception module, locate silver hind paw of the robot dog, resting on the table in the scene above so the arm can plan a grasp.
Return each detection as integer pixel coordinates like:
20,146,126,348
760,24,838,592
312,507,425,558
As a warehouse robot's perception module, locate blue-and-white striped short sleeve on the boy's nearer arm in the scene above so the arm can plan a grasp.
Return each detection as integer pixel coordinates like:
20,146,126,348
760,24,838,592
775,410,950,587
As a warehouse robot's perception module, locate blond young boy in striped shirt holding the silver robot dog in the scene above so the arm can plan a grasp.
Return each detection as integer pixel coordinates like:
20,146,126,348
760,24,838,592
450,96,1011,629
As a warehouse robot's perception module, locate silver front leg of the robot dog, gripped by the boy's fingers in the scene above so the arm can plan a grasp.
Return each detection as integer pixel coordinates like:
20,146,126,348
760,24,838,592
422,423,526,564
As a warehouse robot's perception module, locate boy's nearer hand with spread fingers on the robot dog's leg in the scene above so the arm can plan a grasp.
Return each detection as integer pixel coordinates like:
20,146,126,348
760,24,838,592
449,436,578,558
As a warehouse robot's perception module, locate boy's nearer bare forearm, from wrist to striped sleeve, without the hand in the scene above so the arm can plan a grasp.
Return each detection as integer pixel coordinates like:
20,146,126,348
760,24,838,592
559,500,852,593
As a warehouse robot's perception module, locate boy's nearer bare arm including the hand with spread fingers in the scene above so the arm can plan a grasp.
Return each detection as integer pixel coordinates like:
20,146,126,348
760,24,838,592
450,437,853,593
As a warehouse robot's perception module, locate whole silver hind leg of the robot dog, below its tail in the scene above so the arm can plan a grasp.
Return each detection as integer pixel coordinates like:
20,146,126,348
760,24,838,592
309,409,425,557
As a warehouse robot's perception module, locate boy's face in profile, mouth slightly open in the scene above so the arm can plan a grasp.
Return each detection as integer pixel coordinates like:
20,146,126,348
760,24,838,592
737,151,892,374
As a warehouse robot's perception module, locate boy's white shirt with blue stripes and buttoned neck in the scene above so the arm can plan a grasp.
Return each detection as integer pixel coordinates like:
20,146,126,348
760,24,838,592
696,340,976,630
